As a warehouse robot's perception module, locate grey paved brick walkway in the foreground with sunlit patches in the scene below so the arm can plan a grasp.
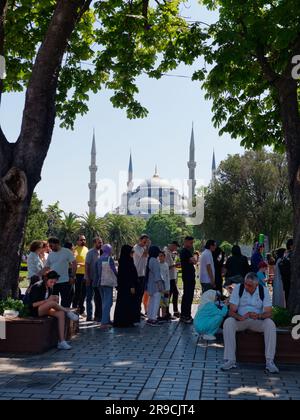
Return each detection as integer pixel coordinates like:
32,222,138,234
0,322,300,400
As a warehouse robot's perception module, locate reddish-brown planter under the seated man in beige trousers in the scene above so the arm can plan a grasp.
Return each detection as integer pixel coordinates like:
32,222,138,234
237,328,300,364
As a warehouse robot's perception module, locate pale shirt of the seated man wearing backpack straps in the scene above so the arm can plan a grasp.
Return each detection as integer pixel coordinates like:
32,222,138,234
230,285,272,316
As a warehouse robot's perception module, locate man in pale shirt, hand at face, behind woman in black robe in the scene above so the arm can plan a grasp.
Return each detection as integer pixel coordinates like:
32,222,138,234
133,235,151,322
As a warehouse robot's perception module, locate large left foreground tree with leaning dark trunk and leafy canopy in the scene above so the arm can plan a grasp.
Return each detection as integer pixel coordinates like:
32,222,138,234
0,0,187,297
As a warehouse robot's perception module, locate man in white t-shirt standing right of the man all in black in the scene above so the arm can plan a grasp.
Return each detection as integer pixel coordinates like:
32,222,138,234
200,239,217,293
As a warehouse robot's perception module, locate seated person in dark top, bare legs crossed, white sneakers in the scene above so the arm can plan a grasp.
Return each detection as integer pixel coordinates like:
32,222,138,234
28,271,79,350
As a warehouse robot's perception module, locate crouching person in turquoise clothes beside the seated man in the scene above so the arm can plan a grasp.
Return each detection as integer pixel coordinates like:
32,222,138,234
194,290,228,341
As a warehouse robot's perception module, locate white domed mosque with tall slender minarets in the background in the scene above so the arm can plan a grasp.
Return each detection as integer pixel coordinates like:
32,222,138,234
88,127,216,219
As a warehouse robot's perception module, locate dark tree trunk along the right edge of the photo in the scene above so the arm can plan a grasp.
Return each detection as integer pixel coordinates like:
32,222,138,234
274,78,300,315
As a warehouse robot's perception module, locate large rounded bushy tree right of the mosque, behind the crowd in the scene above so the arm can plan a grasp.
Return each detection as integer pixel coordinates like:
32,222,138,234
204,151,292,249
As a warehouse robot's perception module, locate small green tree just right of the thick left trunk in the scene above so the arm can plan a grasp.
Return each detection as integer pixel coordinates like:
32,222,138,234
24,193,48,250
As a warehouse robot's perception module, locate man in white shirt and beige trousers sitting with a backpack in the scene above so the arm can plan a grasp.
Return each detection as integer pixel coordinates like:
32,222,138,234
222,273,279,373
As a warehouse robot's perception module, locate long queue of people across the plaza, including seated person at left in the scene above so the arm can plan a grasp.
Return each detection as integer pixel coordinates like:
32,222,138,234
25,231,293,356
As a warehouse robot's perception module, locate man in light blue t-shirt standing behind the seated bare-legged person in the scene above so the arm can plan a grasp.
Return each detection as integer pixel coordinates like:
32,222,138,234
46,238,77,308
